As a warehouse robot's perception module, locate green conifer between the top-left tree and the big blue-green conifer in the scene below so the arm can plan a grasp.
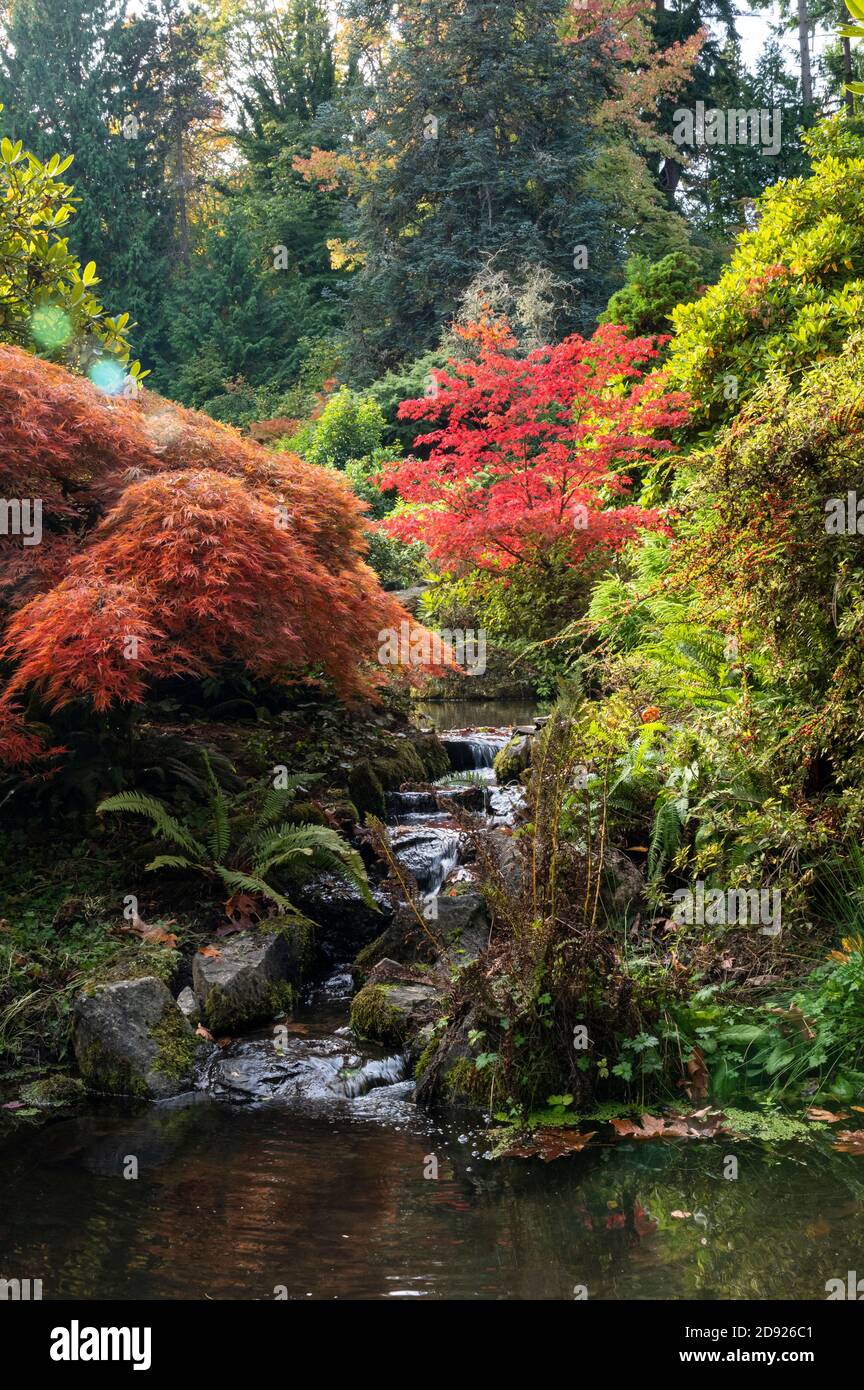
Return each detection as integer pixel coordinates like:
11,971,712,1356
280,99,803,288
161,0,346,411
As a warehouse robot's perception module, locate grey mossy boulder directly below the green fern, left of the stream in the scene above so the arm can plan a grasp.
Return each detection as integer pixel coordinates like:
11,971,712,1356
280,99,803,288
192,931,297,1033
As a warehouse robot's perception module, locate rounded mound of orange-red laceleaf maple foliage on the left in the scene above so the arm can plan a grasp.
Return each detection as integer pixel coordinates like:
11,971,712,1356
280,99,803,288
0,346,433,762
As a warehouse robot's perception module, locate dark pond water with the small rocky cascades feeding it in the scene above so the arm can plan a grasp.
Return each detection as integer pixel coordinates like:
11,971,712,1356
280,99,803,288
0,706,864,1300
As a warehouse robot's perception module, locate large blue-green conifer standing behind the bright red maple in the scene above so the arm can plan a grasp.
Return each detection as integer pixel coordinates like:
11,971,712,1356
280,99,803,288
333,0,615,379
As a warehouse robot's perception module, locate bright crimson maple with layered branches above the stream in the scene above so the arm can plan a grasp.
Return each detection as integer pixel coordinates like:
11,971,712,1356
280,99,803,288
381,320,688,573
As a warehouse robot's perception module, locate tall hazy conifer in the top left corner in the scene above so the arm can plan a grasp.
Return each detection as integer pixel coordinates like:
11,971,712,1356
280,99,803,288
0,0,208,366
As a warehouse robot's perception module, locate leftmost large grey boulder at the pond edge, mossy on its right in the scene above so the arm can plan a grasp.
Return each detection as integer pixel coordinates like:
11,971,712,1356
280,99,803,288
72,976,200,1099
